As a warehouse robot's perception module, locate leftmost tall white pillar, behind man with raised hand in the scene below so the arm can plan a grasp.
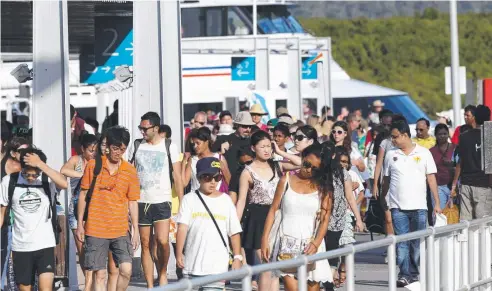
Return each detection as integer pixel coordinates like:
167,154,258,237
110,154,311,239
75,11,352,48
32,0,74,288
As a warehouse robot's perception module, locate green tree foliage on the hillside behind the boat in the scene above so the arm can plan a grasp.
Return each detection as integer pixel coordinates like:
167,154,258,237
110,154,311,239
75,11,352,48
300,9,492,115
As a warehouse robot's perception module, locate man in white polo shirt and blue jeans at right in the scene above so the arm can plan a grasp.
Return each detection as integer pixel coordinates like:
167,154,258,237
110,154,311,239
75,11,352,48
382,120,441,287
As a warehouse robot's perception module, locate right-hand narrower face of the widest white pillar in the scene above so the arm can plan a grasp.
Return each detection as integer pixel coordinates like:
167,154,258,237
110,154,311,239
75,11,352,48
159,0,184,149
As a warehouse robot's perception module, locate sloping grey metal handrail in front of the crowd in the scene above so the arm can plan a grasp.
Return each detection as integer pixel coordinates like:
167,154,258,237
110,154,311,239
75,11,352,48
151,217,492,291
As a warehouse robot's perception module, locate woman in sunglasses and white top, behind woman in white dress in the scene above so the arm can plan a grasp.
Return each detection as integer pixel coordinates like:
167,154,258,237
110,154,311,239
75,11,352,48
330,121,366,174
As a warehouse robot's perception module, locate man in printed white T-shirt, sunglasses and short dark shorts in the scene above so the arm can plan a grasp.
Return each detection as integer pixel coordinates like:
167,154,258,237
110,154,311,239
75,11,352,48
130,112,184,289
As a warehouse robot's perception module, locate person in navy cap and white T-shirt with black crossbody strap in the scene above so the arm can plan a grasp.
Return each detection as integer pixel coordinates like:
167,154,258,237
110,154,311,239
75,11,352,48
176,157,243,290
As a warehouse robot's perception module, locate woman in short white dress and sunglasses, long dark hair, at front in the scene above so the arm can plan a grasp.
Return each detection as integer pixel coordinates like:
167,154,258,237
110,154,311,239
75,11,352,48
261,144,333,291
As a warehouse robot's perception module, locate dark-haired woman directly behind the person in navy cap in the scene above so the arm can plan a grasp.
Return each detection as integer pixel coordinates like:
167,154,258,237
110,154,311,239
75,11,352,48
181,127,231,192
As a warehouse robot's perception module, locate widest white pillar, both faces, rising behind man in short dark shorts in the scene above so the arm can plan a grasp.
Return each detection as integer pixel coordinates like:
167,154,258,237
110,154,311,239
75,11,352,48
133,0,183,149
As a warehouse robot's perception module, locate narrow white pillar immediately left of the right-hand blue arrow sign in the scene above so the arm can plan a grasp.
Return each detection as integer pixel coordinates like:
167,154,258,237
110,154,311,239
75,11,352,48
287,38,303,120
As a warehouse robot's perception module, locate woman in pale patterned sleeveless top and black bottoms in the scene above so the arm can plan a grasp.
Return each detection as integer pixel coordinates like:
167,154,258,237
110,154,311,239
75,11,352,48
236,131,282,290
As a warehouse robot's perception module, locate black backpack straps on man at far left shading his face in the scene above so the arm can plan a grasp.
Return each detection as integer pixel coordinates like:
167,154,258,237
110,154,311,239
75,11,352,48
7,172,61,245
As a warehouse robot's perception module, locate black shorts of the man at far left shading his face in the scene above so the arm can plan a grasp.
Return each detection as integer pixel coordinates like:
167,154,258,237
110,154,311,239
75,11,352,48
12,248,56,286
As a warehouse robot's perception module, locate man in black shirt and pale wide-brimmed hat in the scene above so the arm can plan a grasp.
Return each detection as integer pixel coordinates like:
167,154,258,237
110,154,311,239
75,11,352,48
212,111,256,173
